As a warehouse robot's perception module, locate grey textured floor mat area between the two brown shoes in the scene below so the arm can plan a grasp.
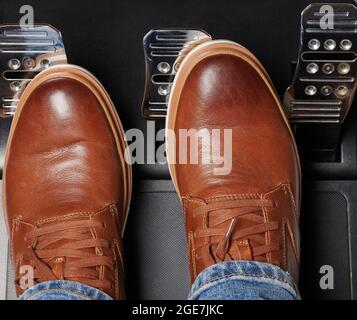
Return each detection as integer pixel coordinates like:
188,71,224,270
124,180,190,300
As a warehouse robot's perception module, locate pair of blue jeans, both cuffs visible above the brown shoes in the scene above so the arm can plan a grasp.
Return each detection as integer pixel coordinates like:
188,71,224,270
20,261,300,300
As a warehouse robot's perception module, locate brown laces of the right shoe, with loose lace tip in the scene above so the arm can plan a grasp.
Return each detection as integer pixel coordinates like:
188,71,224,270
194,199,279,264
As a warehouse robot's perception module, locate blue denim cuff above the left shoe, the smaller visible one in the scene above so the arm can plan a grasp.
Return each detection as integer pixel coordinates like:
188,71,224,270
19,280,113,300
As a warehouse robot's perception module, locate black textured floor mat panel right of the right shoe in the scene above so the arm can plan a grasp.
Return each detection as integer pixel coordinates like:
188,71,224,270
300,186,353,299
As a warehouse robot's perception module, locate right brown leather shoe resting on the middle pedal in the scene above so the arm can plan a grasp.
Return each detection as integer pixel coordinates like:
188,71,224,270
167,41,300,281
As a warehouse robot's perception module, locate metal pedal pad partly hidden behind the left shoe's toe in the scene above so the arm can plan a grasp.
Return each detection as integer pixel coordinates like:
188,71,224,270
0,24,67,175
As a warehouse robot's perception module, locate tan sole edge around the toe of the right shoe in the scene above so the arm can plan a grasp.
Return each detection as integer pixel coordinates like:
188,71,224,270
166,40,301,208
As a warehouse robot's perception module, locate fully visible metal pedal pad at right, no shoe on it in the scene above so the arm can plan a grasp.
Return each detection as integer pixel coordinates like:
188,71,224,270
284,3,357,125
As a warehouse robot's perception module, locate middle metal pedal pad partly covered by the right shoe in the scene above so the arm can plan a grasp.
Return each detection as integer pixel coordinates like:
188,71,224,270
142,29,212,120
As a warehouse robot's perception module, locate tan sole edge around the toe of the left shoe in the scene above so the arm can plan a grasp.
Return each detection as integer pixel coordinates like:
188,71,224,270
2,64,132,237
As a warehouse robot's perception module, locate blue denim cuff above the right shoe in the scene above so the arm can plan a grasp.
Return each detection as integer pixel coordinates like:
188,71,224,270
189,261,300,300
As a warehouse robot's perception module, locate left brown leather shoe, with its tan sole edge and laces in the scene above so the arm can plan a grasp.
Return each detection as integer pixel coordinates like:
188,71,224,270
3,65,131,298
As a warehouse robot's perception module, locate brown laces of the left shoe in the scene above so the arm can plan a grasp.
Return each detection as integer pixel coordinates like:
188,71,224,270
18,220,114,289
